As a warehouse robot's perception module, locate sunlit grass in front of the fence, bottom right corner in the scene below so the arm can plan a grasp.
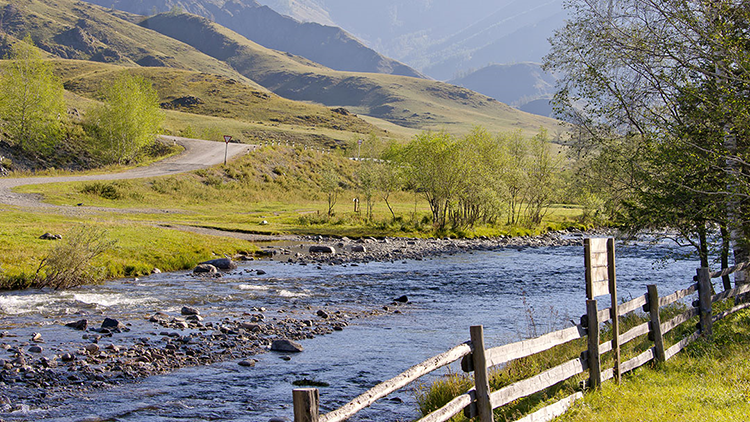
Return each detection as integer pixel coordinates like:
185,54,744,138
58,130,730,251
557,304,750,422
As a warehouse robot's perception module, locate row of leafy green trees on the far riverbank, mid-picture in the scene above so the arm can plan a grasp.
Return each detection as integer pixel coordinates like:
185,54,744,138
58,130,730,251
356,127,562,230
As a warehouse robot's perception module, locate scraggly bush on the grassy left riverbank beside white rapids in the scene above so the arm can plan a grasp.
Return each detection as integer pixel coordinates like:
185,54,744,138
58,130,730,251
34,226,116,290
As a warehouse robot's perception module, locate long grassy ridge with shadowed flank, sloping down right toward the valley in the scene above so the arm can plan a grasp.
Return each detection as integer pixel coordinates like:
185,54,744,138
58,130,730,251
141,13,557,137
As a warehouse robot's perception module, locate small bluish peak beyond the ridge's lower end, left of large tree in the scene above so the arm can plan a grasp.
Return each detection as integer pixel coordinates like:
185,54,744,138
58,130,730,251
449,63,556,116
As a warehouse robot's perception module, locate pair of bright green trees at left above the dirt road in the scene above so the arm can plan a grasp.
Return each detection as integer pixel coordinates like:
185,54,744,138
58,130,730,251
0,36,163,163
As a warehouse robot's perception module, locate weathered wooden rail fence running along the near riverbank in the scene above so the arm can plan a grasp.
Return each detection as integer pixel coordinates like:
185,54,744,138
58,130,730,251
293,264,750,422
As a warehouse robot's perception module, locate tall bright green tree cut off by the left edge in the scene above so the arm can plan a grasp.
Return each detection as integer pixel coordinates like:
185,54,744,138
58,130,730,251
0,35,67,154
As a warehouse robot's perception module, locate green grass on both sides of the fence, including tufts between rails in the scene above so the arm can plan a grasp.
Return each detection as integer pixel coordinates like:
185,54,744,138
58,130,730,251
417,300,750,422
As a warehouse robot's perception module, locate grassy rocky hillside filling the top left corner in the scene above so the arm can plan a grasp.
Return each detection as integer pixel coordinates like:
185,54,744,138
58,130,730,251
0,0,262,89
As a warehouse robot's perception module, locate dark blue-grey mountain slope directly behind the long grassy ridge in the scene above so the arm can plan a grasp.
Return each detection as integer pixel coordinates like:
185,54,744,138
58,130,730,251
87,0,423,77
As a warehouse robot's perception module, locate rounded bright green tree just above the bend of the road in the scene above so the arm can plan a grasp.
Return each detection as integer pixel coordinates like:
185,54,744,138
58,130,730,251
92,73,164,164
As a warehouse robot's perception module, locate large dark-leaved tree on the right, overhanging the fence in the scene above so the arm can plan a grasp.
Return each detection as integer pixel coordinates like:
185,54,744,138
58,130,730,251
545,0,750,283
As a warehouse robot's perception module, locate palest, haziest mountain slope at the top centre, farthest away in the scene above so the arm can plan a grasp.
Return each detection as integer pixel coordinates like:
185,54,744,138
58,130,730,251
258,0,566,80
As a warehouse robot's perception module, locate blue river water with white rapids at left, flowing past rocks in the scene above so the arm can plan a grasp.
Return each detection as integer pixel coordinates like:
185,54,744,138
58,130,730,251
0,239,698,422
